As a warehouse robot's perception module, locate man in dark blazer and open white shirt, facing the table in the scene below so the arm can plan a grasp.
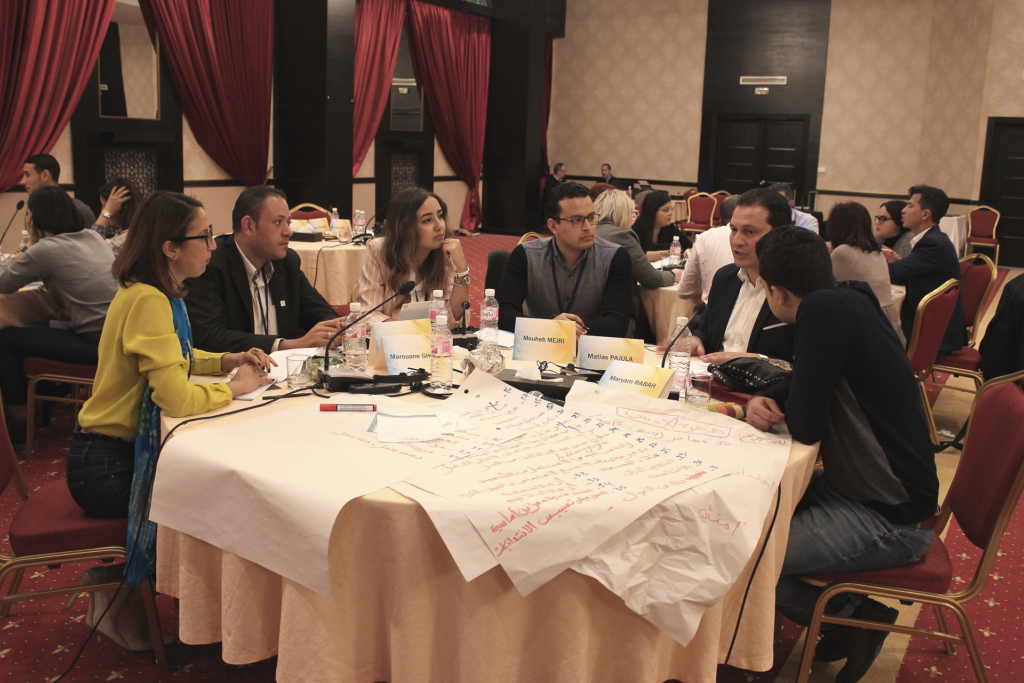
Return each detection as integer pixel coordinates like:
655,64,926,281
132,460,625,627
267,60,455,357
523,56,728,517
690,187,793,362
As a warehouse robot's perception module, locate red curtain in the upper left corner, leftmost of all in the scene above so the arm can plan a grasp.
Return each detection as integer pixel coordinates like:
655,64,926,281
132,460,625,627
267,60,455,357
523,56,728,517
0,0,115,191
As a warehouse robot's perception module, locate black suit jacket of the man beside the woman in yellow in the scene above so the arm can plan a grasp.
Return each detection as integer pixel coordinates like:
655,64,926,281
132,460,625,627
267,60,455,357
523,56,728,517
184,234,338,353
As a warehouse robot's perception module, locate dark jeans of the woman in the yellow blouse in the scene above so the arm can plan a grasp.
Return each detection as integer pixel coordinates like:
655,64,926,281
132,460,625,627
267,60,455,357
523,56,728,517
68,427,135,519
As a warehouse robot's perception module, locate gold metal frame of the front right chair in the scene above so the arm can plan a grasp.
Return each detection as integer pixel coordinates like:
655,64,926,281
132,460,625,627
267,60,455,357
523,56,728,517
797,370,1024,683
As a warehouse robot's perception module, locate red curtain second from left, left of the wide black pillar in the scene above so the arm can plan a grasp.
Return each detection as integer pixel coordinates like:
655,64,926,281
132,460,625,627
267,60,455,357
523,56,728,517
140,0,273,185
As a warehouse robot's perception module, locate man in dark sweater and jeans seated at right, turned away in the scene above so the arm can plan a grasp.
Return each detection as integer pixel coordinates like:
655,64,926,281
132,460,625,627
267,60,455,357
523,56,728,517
746,225,939,683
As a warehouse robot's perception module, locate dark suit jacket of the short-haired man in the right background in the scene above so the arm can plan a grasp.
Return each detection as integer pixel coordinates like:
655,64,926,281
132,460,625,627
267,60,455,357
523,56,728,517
889,225,967,354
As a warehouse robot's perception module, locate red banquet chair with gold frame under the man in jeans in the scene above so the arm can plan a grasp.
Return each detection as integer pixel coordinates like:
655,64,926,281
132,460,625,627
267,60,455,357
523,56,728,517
797,372,1024,683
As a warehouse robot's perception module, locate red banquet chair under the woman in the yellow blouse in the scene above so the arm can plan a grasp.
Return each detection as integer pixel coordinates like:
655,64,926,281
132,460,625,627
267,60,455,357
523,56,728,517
0,393,168,672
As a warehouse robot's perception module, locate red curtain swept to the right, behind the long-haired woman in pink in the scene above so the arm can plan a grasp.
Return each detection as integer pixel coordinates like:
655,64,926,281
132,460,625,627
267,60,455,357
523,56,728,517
409,0,490,230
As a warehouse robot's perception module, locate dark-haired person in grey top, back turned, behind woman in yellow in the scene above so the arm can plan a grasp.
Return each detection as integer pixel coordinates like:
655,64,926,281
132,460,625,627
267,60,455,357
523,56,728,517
0,185,117,442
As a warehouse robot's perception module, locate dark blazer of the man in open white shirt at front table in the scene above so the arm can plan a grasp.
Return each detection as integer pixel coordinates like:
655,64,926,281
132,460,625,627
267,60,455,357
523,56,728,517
690,263,793,360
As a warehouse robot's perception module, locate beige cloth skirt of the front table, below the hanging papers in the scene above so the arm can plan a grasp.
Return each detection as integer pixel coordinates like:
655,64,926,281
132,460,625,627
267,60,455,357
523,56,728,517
157,443,817,683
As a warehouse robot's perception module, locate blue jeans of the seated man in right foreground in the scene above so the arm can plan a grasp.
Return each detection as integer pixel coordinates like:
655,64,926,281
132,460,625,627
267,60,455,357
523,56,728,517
775,469,934,626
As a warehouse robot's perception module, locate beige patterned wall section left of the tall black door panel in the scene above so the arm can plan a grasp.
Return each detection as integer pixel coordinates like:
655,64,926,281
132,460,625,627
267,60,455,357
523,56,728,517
548,0,708,181
